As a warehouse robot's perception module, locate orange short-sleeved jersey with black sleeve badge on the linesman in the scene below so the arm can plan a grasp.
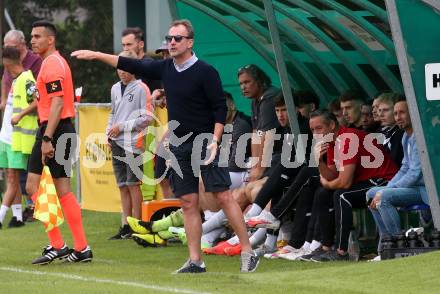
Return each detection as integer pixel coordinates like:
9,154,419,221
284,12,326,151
36,51,75,123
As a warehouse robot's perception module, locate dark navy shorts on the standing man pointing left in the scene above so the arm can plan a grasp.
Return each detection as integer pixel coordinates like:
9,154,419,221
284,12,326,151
170,141,231,197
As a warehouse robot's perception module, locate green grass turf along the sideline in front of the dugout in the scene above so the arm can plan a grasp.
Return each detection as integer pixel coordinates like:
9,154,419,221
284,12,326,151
0,211,440,294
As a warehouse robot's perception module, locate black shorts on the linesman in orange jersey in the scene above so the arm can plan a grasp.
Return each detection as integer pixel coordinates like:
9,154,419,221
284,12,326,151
28,118,78,179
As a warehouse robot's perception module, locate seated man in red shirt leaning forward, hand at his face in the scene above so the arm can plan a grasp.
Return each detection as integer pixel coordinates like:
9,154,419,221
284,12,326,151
310,111,397,262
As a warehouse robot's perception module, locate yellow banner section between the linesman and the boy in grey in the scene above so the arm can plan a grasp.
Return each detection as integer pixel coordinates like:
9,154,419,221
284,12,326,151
77,104,121,212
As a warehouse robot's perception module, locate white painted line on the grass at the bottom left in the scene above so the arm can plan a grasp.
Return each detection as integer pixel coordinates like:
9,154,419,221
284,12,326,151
0,267,208,294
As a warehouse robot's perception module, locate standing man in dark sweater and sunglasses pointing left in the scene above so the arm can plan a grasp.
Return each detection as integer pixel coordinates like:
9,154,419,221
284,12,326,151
72,20,259,273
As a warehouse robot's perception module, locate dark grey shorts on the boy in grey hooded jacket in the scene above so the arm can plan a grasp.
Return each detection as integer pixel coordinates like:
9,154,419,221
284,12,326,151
111,141,144,187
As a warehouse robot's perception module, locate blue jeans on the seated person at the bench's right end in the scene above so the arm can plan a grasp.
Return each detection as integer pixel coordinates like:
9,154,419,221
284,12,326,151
367,187,423,238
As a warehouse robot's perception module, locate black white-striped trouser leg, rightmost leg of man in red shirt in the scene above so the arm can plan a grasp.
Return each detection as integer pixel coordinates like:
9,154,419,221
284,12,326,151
333,179,387,251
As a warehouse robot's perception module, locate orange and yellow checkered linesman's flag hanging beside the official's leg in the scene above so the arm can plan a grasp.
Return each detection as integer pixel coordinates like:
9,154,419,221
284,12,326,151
34,166,64,232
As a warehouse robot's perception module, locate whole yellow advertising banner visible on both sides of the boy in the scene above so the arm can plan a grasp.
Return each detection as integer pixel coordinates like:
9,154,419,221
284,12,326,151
77,103,167,212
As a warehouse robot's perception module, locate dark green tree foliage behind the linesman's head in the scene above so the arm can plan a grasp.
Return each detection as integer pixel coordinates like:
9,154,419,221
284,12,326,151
5,0,117,103
